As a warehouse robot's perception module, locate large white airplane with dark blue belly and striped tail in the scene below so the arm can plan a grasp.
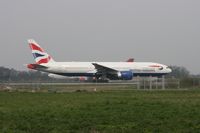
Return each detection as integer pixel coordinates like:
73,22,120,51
27,39,172,80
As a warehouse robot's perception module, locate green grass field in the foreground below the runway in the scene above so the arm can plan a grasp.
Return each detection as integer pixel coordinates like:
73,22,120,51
0,90,200,133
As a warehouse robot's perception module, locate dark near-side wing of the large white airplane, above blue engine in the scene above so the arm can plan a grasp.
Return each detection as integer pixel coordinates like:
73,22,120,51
92,63,118,74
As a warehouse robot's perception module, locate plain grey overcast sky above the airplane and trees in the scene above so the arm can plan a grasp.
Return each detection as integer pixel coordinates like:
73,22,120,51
0,0,200,74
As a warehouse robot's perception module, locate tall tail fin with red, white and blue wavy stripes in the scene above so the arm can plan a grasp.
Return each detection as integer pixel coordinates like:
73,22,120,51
28,39,54,64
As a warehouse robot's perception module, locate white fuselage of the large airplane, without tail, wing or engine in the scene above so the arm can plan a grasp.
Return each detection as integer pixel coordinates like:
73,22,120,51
40,62,171,77
